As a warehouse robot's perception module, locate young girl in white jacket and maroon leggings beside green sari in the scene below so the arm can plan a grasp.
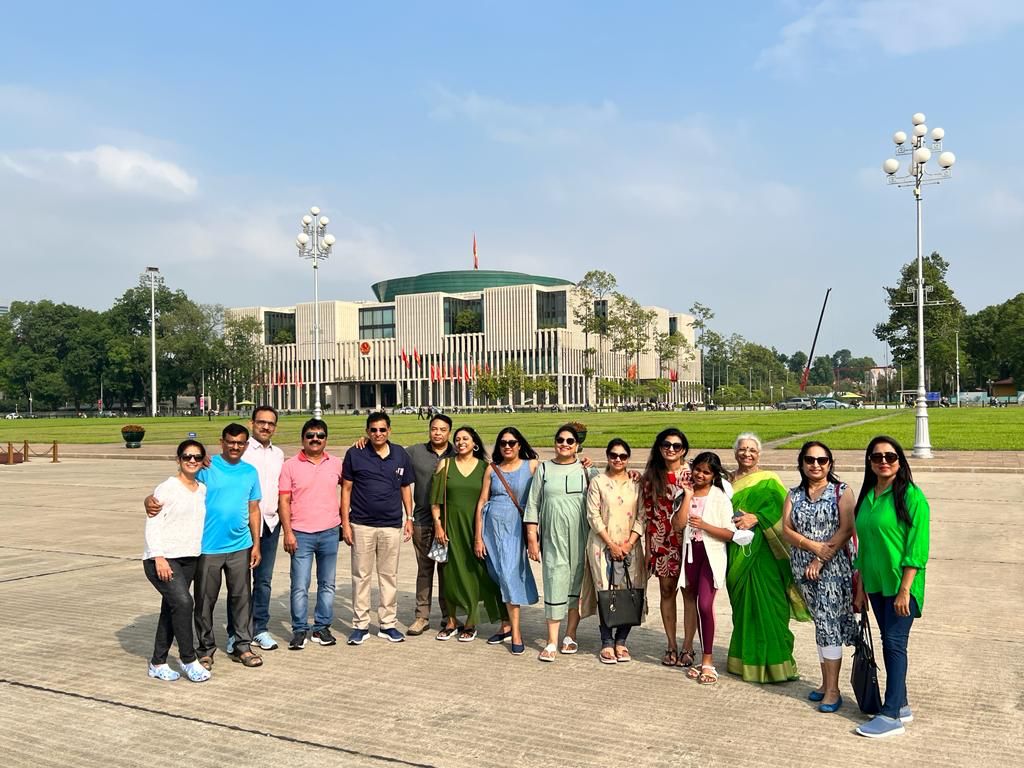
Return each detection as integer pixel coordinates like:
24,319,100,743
673,453,736,685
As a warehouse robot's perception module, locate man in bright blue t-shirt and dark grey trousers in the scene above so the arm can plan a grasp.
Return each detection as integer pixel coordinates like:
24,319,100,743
196,424,263,669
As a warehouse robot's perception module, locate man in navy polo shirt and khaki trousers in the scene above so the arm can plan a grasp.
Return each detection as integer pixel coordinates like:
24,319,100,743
341,412,416,645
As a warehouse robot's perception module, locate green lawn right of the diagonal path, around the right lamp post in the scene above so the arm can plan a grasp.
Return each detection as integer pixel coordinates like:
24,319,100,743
783,408,1024,451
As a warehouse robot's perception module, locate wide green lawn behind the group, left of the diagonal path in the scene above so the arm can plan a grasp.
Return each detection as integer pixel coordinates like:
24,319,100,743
0,411,864,449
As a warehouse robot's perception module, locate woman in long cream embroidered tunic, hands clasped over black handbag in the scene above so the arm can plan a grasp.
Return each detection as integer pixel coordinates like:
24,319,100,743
582,437,647,664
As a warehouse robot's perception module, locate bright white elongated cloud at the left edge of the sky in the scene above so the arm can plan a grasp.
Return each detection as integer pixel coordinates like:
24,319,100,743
0,144,199,199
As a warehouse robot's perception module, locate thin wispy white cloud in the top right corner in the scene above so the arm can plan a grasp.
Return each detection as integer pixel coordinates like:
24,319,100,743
756,0,1024,73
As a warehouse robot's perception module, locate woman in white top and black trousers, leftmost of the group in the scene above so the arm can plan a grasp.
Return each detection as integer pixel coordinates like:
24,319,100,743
142,440,210,683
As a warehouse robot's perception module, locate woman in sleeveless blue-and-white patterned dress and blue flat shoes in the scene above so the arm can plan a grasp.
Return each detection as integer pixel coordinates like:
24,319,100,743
782,440,857,713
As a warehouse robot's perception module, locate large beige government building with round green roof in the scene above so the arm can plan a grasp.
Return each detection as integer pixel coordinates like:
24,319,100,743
225,269,703,412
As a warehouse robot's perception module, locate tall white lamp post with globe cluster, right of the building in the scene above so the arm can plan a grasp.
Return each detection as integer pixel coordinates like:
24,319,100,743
882,112,956,459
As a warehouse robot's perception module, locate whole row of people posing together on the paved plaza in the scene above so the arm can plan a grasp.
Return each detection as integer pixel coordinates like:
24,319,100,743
143,406,929,737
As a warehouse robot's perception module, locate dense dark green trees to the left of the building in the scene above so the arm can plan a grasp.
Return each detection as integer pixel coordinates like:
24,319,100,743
0,280,262,412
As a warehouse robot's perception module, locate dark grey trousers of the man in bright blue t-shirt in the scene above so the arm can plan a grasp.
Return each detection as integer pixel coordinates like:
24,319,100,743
196,547,253,656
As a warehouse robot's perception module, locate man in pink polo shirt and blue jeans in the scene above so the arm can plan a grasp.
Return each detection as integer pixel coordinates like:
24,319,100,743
278,419,342,650
